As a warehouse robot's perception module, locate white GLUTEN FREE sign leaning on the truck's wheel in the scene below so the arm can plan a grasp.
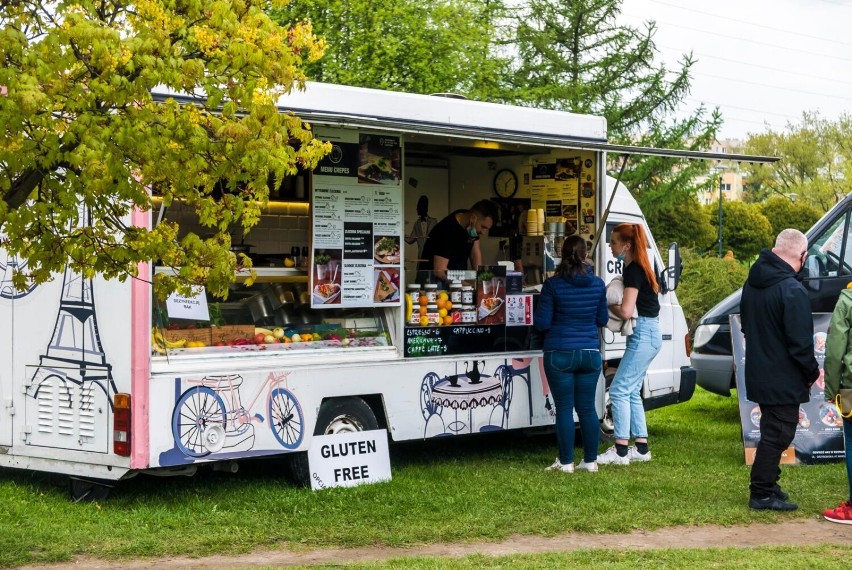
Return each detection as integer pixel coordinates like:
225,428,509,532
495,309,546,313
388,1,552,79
308,429,391,491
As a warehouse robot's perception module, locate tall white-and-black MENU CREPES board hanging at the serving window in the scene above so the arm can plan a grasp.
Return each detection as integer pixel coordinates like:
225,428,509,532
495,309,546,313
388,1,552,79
310,129,403,308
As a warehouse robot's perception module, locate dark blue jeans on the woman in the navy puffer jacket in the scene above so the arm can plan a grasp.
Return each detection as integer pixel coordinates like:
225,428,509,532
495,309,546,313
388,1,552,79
544,350,601,465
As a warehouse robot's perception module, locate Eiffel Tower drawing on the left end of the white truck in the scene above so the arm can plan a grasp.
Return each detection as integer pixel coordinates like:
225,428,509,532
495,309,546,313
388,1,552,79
31,210,118,409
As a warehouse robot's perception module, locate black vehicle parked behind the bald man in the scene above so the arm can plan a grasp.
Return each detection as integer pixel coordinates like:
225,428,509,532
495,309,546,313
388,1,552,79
690,194,852,396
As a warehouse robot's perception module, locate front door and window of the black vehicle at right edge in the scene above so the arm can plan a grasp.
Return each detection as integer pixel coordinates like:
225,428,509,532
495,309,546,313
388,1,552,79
802,208,852,313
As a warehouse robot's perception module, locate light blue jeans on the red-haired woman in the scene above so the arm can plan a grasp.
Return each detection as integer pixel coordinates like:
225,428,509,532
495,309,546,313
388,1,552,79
609,317,663,439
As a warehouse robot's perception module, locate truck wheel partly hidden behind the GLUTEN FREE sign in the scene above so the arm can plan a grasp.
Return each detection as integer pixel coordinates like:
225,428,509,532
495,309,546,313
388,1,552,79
289,398,379,487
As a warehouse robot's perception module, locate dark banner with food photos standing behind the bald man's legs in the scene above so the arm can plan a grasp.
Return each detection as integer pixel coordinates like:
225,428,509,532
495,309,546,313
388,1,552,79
730,313,845,465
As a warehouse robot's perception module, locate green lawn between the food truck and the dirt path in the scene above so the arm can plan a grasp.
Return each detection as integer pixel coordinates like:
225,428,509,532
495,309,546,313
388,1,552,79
0,390,848,568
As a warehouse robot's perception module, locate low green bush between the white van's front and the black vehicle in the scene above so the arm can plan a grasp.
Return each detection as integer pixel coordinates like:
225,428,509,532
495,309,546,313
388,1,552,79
677,250,748,330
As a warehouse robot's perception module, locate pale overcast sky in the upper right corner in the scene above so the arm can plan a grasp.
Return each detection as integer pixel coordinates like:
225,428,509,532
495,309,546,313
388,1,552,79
622,0,852,139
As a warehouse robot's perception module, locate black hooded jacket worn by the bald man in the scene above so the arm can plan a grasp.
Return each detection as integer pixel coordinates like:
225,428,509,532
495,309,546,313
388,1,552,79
740,249,819,406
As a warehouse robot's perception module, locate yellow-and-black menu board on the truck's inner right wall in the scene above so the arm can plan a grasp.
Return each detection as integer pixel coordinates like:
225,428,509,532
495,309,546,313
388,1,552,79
530,151,597,239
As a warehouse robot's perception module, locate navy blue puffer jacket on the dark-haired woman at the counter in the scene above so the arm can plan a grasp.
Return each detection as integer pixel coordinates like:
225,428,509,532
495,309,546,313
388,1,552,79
534,267,609,350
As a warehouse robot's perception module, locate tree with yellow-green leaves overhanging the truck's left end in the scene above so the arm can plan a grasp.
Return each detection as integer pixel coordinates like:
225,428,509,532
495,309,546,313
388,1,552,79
0,0,329,296
